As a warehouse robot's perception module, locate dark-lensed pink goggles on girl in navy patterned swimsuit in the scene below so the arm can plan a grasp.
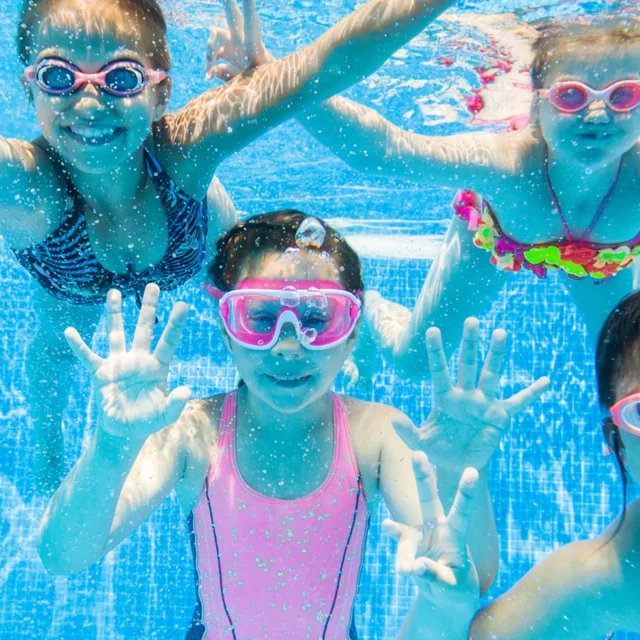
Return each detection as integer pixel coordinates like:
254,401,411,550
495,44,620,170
24,58,167,98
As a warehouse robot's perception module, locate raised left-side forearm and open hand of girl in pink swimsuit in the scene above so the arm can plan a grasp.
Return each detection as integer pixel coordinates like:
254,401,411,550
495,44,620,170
38,284,188,574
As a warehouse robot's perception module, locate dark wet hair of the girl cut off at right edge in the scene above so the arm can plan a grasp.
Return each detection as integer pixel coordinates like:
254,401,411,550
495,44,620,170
596,291,640,535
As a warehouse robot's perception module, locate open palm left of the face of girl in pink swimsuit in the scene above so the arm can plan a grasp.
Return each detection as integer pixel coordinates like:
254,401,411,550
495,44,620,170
65,284,190,442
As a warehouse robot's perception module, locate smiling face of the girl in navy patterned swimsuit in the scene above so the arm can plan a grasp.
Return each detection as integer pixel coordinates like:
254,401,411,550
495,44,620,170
29,11,164,174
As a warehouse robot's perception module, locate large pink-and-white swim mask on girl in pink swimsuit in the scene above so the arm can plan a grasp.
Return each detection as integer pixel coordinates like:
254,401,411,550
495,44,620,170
203,278,362,350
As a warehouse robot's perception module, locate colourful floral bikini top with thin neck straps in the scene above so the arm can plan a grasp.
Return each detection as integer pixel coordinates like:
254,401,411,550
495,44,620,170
453,158,640,280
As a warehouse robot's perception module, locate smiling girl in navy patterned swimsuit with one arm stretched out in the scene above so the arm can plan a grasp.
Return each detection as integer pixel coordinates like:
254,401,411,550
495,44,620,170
0,0,468,492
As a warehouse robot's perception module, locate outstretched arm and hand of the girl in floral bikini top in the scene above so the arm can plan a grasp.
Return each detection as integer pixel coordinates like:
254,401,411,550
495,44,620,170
207,0,527,191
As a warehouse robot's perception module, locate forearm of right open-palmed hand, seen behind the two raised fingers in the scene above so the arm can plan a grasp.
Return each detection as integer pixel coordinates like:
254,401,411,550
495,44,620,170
437,468,500,593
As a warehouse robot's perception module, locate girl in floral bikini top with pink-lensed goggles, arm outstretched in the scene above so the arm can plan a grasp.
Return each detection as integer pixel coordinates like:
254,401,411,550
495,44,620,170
209,3,640,378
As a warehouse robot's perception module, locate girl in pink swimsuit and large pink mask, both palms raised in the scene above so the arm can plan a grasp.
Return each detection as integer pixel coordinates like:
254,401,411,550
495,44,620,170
39,211,546,640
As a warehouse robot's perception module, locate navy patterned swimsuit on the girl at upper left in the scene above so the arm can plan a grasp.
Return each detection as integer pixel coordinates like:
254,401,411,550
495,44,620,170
13,149,208,306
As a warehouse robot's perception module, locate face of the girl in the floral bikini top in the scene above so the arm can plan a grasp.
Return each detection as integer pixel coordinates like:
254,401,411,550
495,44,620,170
539,44,640,166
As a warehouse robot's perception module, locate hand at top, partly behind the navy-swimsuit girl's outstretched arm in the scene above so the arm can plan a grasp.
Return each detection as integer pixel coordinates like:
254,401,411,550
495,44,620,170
207,0,271,81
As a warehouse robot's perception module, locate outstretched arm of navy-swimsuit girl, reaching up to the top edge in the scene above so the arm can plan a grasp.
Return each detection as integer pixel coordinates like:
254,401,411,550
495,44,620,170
163,0,460,194
